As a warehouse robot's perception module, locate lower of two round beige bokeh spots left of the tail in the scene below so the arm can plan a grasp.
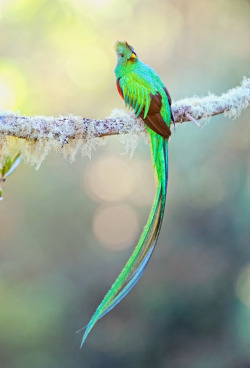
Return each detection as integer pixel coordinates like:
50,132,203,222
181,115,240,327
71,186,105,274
94,205,139,250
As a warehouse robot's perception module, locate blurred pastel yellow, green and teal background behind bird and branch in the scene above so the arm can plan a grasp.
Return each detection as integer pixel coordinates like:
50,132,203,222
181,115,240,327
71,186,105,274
0,0,250,368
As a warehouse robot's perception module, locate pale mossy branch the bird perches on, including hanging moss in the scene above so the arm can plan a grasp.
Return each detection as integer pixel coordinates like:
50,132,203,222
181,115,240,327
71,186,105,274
0,78,250,166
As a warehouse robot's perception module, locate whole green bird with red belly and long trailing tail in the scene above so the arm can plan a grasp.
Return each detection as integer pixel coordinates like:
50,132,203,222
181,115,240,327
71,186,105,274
79,42,174,347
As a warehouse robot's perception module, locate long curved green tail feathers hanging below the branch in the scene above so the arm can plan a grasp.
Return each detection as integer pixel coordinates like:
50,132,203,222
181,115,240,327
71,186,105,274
79,129,168,347
